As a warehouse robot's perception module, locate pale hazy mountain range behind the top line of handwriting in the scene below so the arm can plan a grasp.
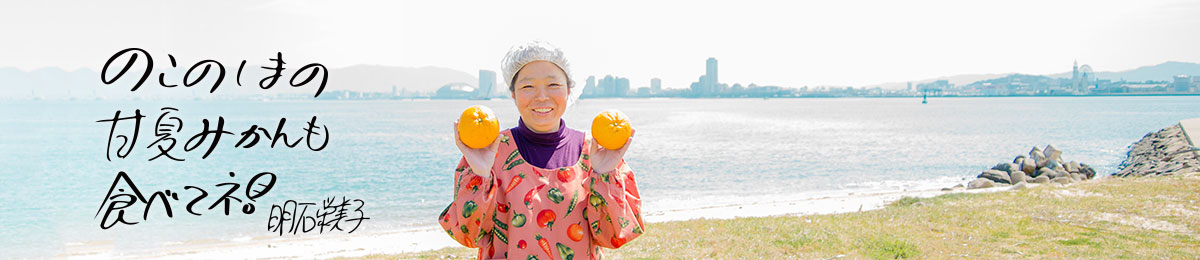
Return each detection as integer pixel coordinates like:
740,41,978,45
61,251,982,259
0,65,479,99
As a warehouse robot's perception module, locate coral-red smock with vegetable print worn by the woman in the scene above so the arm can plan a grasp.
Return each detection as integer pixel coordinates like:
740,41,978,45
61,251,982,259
438,129,643,260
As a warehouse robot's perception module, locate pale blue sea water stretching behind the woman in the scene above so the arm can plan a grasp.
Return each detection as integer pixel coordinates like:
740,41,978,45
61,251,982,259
0,96,1200,256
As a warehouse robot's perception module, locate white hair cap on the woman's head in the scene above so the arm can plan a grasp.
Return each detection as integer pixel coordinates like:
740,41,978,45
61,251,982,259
500,41,583,107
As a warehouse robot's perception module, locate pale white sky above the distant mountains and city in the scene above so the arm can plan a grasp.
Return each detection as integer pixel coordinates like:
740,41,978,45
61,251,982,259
0,0,1200,87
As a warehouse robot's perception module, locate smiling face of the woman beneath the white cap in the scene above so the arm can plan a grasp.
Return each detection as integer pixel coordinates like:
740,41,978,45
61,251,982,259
512,61,570,133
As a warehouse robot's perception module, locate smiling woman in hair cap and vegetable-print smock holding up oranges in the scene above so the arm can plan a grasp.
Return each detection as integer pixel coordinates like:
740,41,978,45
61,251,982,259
438,42,643,260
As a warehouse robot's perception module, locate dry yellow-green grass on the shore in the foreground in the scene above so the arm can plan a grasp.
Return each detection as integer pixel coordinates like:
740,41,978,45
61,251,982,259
345,174,1200,259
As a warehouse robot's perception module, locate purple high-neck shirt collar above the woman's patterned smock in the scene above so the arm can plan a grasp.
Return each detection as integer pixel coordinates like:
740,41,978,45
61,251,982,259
512,119,584,169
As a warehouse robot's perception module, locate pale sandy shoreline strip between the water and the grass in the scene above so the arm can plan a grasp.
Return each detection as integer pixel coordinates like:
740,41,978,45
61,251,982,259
52,177,993,259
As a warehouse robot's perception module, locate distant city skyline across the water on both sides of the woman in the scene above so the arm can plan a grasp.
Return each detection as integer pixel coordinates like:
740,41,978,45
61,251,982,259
333,58,1200,99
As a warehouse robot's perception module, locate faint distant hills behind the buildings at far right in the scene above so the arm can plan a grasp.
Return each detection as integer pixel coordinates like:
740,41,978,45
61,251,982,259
868,61,1200,89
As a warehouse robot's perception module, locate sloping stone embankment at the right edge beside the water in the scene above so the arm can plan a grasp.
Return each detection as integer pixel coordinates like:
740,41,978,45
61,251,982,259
1112,125,1200,177
